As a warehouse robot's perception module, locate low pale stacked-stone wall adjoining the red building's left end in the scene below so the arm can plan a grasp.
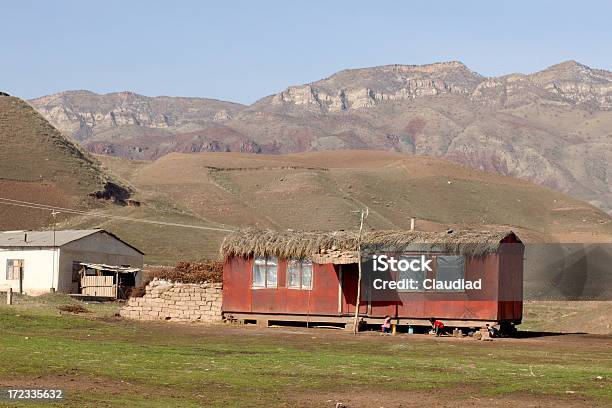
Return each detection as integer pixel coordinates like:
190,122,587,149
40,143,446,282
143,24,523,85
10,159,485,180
120,279,223,323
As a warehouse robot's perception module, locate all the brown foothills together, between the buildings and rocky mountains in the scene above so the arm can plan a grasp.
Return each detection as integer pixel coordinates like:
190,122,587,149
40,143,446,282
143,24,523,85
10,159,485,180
0,89,612,264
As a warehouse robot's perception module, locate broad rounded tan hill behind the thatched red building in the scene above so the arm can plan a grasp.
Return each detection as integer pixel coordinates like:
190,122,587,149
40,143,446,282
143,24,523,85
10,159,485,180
89,151,612,262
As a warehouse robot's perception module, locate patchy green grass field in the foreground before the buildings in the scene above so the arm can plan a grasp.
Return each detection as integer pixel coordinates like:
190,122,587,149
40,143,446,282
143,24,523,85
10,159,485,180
0,295,612,407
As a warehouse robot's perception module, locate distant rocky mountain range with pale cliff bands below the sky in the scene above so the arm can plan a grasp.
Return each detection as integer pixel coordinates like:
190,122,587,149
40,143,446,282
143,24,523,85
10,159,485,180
29,61,612,213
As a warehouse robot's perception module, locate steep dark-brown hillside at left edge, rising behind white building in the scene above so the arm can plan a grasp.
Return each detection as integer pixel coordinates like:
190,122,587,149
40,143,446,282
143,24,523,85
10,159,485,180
0,96,129,230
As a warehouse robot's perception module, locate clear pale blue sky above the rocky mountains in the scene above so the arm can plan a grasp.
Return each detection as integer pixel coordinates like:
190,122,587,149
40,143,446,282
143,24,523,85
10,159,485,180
0,0,612,103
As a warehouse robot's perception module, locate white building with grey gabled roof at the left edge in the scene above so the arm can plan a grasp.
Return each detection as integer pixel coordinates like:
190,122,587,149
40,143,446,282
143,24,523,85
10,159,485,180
0,229,144,295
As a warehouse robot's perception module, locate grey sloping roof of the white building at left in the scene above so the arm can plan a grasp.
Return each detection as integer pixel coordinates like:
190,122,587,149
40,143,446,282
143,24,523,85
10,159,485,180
0,229,103,248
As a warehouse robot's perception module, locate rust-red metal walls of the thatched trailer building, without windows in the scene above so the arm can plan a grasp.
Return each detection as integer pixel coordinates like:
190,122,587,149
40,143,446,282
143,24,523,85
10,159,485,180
223,245,523,321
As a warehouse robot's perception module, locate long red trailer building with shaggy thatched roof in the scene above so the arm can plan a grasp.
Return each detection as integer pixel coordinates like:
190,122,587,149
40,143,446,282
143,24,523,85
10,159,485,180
222,229,524,327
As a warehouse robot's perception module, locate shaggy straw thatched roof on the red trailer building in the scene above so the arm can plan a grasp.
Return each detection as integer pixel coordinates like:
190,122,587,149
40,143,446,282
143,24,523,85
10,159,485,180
221,229,520,263
